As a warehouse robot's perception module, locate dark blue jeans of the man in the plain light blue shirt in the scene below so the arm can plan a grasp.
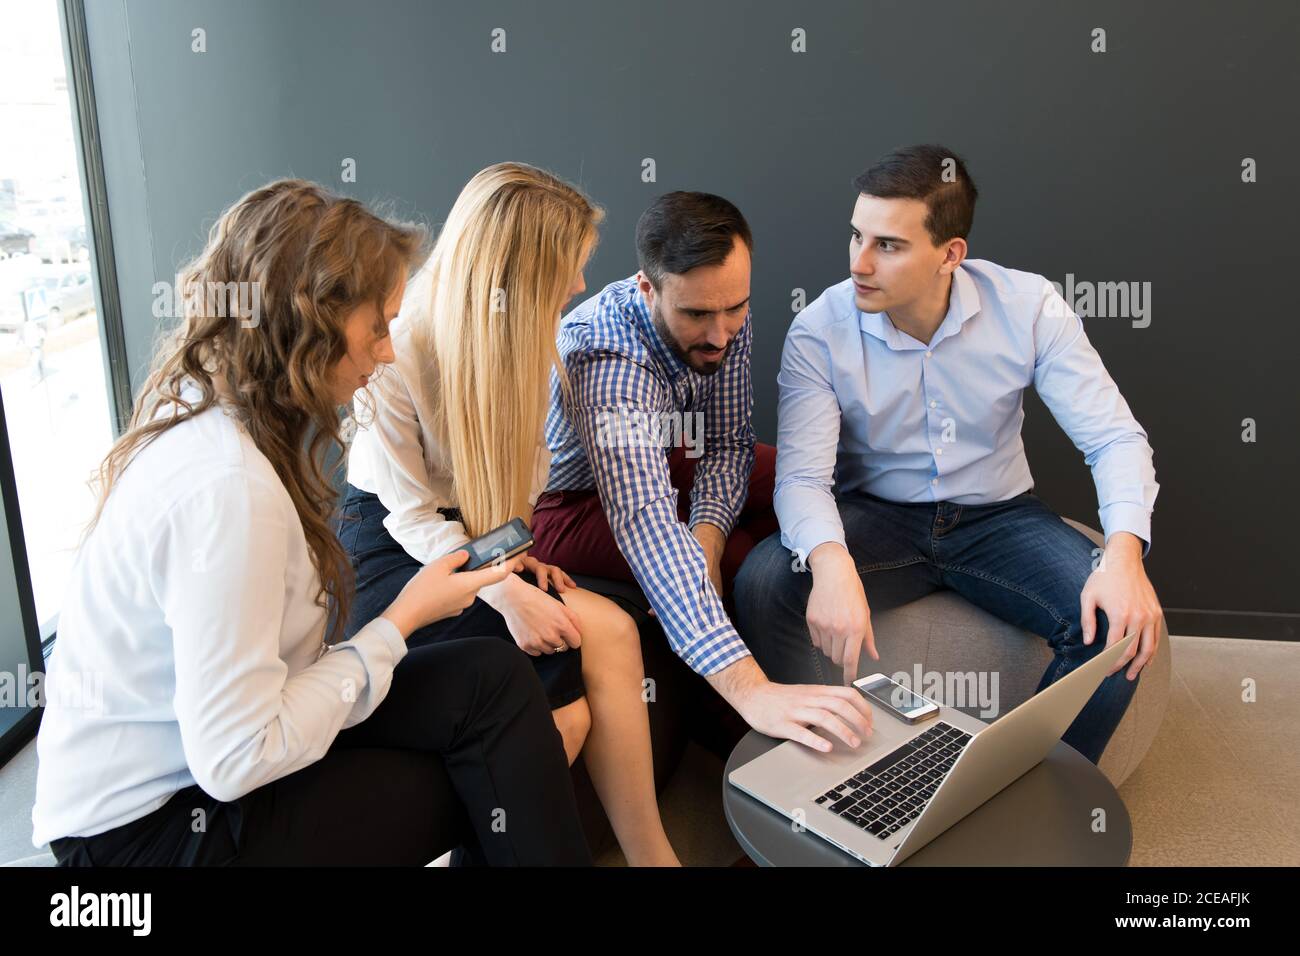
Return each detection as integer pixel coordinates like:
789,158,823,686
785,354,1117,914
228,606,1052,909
736,492,1138,763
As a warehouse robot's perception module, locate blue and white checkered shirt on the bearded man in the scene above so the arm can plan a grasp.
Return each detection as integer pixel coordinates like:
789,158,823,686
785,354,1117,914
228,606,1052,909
546,276,754,675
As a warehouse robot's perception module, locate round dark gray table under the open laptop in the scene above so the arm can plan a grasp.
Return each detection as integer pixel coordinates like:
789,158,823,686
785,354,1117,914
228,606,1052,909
723,731,1132,866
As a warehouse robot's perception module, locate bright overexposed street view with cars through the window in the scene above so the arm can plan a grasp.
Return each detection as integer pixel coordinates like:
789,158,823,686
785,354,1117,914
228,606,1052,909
0,0,113,630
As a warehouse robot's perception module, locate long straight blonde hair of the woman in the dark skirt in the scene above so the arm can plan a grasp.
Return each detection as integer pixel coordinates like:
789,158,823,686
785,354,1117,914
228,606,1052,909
408,163,605,536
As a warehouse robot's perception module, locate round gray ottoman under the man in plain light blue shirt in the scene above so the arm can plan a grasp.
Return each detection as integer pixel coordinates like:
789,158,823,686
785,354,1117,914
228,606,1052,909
859,519,1170,787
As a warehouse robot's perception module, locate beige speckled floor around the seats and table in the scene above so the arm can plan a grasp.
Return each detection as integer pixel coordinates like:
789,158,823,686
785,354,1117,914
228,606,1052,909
0,637,1300,866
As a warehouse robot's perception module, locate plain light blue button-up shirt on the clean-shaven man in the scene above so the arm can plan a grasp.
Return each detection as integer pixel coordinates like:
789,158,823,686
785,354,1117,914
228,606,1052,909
776,259,1160,559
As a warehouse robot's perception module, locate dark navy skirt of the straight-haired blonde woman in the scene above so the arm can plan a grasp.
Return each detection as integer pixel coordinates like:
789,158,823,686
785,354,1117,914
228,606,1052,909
335,485,586,710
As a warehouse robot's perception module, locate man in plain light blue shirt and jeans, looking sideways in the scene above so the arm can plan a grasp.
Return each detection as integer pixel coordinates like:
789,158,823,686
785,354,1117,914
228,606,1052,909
736,146,1162,762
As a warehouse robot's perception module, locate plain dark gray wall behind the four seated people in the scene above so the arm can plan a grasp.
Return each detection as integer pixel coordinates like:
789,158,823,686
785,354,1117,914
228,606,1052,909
88,0,1300,637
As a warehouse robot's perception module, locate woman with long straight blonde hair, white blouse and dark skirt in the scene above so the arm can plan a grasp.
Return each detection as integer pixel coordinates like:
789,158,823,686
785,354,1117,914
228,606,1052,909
339,163,677,866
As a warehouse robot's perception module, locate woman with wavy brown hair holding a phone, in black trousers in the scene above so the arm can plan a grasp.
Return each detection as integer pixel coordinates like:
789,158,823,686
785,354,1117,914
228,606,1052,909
33,179,589,866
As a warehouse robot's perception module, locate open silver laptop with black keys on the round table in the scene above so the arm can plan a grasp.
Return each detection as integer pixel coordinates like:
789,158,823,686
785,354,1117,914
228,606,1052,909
727,633,1138,866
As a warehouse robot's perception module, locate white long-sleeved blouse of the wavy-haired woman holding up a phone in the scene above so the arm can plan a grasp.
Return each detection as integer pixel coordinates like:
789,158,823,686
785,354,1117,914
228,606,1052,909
31,392,407,847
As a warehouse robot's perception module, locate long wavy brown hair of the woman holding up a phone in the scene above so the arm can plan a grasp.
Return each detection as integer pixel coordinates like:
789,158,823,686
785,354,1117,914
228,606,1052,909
86,179,426,637
